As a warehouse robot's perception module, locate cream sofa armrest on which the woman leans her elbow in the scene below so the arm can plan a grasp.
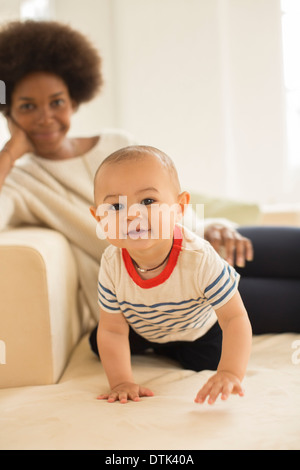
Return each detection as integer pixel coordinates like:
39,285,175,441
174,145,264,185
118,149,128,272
0,228,81,388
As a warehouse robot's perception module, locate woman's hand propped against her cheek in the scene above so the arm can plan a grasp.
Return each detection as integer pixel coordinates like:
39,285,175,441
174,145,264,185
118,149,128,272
5,116,35,162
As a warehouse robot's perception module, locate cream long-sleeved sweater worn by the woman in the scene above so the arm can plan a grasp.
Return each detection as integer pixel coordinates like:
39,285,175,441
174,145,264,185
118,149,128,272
0,131,135,326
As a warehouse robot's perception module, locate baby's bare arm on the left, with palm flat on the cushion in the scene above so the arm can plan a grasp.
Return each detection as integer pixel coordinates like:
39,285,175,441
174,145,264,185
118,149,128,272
97,309,153,403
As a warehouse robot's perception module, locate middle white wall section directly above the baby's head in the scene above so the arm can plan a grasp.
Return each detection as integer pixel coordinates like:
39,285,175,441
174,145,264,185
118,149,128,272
113,0,225,193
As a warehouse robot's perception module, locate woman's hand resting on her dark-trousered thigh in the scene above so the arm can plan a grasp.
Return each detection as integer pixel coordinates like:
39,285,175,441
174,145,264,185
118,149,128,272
204,224,253,268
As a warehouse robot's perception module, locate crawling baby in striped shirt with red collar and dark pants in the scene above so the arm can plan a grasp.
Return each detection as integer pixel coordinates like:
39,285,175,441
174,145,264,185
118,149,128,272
90,146,252,404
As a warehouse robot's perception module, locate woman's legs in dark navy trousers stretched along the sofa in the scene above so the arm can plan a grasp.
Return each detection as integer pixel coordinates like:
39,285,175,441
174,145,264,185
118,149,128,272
236,227,300,334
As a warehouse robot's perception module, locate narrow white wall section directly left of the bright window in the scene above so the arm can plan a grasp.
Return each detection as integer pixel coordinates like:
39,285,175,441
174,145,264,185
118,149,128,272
223,0,286,202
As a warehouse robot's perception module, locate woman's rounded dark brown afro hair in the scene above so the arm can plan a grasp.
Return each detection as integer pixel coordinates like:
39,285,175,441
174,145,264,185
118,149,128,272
0,20,102,113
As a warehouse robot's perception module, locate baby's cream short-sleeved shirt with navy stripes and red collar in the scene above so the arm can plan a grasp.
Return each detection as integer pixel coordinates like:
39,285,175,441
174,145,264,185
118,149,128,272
98,227,239,343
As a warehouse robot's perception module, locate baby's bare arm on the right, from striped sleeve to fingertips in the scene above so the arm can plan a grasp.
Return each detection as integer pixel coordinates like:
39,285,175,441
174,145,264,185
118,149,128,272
195,292,252,404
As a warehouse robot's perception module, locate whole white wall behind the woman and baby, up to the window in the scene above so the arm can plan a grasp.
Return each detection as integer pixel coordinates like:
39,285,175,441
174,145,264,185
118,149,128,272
0,0,295,202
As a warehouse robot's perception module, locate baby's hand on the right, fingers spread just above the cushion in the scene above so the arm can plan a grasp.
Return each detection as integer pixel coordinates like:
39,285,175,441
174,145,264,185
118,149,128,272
195,371,244,405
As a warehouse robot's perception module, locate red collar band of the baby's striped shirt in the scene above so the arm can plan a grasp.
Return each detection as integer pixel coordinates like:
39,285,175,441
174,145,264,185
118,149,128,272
122,225,182,289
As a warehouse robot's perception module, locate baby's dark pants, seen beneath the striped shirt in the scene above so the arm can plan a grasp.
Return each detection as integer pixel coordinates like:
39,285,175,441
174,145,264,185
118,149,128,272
90,323,222,371
